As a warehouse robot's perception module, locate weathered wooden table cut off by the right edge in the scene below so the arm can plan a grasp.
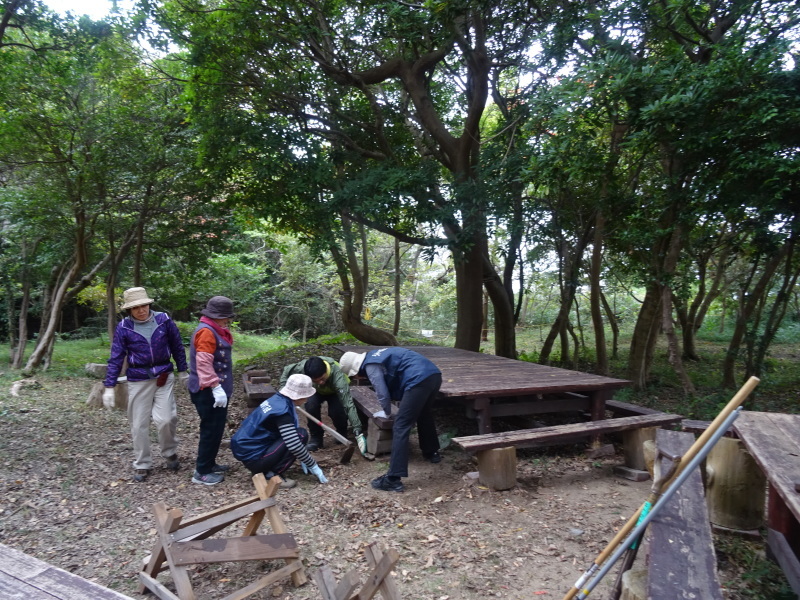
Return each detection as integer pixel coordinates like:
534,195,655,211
733,411,800,596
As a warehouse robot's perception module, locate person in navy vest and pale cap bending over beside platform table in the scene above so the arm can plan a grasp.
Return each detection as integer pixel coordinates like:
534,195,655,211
339,347,442,492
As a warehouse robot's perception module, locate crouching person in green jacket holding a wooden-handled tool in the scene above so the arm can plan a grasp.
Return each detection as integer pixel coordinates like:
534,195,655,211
280,356,367,454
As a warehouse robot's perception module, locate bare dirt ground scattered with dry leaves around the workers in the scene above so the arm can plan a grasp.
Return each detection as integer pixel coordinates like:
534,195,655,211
0,354,768,600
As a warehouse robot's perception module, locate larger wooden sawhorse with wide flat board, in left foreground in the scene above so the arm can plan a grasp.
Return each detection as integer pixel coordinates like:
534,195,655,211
139,473,308,600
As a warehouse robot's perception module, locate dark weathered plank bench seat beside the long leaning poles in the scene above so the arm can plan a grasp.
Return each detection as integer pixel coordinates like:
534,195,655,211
647,429,722,600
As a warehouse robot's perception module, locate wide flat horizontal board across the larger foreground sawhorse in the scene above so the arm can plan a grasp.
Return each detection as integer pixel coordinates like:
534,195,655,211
170,533,300,566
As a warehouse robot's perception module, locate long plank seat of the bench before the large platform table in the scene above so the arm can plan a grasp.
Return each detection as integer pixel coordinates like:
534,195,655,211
452,413,682,453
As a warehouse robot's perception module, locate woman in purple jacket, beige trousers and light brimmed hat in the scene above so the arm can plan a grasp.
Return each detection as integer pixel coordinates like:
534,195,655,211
103,287,189,482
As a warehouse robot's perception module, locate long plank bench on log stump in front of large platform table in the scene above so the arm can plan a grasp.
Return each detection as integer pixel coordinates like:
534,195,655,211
452,413,682,490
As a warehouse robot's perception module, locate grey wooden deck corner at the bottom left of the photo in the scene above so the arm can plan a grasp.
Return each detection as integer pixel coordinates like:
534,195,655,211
0,544,133,600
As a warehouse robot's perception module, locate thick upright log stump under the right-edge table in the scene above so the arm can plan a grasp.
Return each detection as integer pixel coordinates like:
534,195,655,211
706,438,766,531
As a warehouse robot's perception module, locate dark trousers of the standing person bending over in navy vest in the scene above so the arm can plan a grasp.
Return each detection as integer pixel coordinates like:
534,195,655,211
387,373,442,477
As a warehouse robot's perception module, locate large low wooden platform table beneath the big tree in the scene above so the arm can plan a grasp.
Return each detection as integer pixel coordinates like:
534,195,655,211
336,346,630,434
